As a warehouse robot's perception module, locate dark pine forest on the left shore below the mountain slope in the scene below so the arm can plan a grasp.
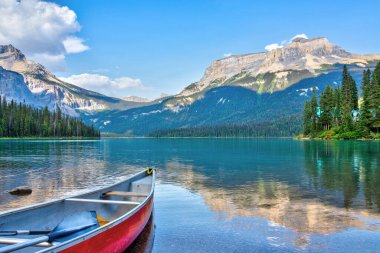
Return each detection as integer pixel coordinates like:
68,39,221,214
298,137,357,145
0,96,100,137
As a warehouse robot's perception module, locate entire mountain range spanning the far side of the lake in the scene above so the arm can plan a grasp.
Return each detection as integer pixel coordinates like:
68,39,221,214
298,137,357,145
0,38,380,135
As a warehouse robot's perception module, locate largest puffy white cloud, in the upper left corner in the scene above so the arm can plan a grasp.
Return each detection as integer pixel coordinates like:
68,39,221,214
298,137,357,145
0,0,88,71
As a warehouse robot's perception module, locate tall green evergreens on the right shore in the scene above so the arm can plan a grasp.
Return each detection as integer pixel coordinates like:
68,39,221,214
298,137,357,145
303,63,380,139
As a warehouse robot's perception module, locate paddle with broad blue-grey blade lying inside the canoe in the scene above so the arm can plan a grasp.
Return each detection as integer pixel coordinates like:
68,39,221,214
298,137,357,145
0,211,99,253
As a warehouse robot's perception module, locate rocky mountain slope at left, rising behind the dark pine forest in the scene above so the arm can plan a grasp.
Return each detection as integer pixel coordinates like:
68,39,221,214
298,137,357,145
0,45,148,115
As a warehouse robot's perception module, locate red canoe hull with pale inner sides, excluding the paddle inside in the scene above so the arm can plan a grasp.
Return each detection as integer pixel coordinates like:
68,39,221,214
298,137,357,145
0,170,155,253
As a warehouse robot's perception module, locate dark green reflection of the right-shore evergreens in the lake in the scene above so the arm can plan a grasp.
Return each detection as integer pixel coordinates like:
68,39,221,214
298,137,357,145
305,142,380,212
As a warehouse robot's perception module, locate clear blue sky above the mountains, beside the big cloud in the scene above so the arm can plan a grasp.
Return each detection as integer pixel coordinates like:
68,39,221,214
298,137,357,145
0,0,380,98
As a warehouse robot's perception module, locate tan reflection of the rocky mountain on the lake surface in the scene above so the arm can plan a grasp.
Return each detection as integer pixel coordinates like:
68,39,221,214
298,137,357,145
162,159,380,234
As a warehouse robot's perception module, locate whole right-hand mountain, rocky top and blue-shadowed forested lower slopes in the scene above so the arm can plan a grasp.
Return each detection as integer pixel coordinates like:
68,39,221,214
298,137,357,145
88,38,380,135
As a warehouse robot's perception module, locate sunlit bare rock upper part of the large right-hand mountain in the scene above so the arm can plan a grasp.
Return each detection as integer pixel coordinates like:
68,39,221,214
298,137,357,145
177,37,380,97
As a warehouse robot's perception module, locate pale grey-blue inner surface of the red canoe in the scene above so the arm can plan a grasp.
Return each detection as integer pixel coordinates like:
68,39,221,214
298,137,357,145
0,172,154,253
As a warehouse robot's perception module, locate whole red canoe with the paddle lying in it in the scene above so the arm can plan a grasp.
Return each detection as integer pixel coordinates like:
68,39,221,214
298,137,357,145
0,169,155,253
